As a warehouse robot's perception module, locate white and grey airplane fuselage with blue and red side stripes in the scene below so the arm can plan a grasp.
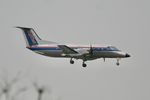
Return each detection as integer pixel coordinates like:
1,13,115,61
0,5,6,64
27,44,126,60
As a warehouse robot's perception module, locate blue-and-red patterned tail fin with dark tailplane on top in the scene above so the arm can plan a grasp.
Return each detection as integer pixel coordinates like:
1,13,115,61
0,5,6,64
16,27,41,47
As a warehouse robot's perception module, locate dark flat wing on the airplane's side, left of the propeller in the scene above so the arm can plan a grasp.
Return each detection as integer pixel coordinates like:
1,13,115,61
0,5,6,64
58,45,78,54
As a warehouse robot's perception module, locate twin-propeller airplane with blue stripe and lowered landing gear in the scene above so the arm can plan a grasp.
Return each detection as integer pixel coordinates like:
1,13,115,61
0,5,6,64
16,27,130,67
